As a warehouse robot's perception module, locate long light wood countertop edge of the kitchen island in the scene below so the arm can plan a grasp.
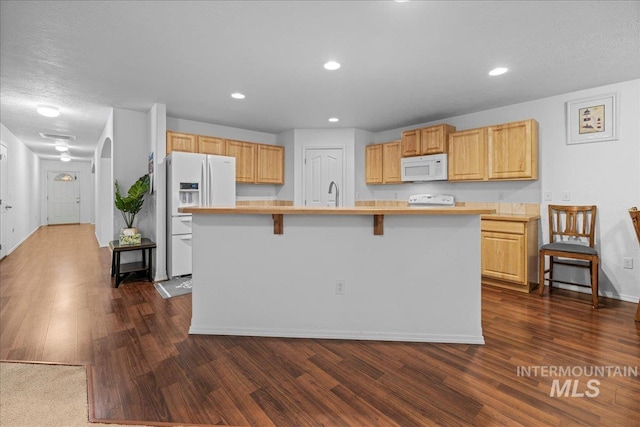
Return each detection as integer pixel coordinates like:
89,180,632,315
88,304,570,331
179,206,495,215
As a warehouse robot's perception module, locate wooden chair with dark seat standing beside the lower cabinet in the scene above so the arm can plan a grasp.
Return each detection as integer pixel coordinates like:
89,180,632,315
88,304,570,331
539,205,600,309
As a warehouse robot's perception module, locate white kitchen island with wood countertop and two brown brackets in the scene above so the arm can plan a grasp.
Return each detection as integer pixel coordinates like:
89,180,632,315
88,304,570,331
182,207,494,344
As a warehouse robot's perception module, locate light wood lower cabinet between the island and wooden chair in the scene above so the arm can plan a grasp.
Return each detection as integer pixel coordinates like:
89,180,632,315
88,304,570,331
481,215,539,292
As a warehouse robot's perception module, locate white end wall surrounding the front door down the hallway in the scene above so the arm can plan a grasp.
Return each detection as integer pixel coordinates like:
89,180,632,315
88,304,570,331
40,160,95,225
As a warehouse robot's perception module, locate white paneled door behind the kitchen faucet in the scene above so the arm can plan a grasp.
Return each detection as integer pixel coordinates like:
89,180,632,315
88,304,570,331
303,148,345,207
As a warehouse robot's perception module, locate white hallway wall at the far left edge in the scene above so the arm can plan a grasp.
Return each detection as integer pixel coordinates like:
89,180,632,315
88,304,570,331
0,123,41,255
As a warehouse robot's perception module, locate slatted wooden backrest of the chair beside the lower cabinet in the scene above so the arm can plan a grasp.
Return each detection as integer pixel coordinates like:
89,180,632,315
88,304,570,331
549,205,596,248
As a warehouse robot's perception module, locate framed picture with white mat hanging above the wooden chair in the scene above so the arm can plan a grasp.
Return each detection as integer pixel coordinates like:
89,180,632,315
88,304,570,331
567,93,618,144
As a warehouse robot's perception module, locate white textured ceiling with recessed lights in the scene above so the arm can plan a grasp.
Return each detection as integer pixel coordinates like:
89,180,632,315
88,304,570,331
0,0,640,160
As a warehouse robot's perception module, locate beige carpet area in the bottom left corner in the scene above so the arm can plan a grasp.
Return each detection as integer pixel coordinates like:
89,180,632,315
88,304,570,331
0,362,151,427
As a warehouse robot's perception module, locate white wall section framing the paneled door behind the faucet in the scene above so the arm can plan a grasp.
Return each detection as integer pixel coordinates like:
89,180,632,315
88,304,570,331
293,128,364,206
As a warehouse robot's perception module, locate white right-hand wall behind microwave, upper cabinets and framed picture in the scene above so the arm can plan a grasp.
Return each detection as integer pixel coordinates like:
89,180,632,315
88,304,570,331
368,80,640,301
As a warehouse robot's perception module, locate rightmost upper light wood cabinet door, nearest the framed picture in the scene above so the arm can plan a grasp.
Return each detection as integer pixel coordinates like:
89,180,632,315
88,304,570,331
487,120,538,179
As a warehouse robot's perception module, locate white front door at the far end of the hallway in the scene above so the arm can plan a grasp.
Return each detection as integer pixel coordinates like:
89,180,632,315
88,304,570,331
47,172,80,225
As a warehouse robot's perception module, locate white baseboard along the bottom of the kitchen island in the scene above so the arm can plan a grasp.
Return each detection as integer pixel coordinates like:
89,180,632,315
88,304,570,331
189,325,484,344
